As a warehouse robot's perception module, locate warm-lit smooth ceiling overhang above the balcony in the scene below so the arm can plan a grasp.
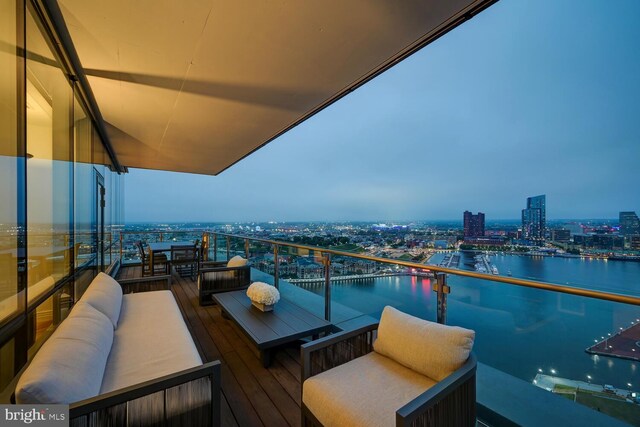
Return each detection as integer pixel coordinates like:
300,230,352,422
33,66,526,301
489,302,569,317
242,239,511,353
59,0,495,175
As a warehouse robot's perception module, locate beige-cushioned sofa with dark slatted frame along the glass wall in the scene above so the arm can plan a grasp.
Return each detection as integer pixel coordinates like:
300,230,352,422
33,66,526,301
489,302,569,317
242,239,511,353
15,273,220,425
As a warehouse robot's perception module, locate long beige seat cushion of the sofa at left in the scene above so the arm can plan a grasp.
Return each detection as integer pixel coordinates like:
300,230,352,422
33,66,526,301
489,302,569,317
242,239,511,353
101,291,202,393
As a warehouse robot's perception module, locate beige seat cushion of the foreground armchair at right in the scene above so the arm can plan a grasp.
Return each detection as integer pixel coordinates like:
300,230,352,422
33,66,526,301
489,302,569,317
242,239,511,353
302,352,436,427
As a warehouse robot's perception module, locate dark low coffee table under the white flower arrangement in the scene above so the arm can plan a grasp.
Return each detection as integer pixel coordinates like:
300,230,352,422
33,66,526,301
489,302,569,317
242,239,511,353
212,291,332,368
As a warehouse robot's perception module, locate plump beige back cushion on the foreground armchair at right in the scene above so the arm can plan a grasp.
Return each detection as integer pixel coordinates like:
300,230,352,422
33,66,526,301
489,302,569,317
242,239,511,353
373,306,475,381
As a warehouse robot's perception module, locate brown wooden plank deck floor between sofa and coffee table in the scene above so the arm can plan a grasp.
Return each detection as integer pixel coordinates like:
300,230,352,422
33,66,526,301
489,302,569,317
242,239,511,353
118,267,301,427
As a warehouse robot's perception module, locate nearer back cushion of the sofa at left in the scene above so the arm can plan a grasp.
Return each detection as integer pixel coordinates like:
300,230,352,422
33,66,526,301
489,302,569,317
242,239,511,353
16,302,113,404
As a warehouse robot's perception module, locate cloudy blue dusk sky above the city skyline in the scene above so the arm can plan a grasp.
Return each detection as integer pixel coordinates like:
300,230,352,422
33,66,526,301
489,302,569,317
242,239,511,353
125,0,640,222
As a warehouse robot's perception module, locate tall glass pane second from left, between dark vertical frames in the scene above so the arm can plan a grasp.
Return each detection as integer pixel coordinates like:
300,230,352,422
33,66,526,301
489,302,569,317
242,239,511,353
26,8,73,304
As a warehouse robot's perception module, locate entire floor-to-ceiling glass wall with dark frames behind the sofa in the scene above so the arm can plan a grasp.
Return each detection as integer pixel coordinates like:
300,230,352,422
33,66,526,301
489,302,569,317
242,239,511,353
0,0,124,403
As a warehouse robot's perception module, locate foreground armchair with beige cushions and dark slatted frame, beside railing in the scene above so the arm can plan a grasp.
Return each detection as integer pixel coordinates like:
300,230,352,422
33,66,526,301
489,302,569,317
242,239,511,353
301,307,476,427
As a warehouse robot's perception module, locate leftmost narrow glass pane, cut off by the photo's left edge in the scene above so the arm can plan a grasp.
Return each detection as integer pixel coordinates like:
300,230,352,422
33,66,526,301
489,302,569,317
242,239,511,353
0,1,26,400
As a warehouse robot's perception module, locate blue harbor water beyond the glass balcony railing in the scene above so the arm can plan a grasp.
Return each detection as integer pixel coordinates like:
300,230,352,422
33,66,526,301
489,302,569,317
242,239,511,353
300,253,640,389
